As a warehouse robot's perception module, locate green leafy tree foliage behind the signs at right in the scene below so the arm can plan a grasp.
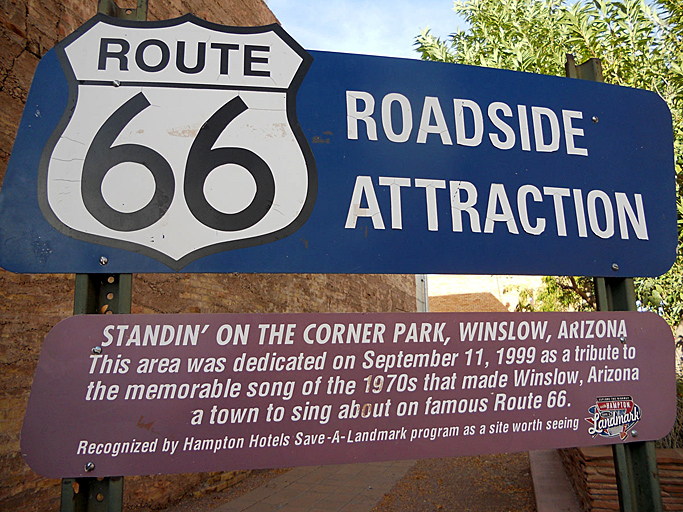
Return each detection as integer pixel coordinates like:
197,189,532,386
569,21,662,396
416,0,683,325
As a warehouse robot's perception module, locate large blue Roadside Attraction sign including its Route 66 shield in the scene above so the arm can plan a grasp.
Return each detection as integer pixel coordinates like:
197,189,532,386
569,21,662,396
0,15,677,276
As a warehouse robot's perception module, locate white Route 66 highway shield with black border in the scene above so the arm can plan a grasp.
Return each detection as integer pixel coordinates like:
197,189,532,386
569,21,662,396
39,15,317,270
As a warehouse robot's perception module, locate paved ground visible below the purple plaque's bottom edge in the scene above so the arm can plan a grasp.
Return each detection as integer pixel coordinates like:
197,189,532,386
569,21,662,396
152,450,579,512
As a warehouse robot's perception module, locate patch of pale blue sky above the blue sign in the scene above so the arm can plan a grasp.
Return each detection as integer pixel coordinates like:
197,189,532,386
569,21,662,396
266,0,465,58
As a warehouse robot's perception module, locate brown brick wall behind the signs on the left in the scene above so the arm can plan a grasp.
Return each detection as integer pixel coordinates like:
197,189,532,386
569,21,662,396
0,0,415,511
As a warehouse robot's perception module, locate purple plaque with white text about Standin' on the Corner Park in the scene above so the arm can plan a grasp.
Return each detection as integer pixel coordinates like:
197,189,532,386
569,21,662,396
21,312,676,478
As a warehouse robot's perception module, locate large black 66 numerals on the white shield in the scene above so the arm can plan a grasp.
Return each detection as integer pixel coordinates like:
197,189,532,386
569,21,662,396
81,92,275,231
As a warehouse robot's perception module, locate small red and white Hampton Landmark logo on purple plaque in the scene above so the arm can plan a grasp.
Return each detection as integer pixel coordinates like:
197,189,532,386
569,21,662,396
586,396,642,441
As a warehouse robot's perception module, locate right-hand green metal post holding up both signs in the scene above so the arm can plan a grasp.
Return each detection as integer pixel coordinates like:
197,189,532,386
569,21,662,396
565,54,663,512
